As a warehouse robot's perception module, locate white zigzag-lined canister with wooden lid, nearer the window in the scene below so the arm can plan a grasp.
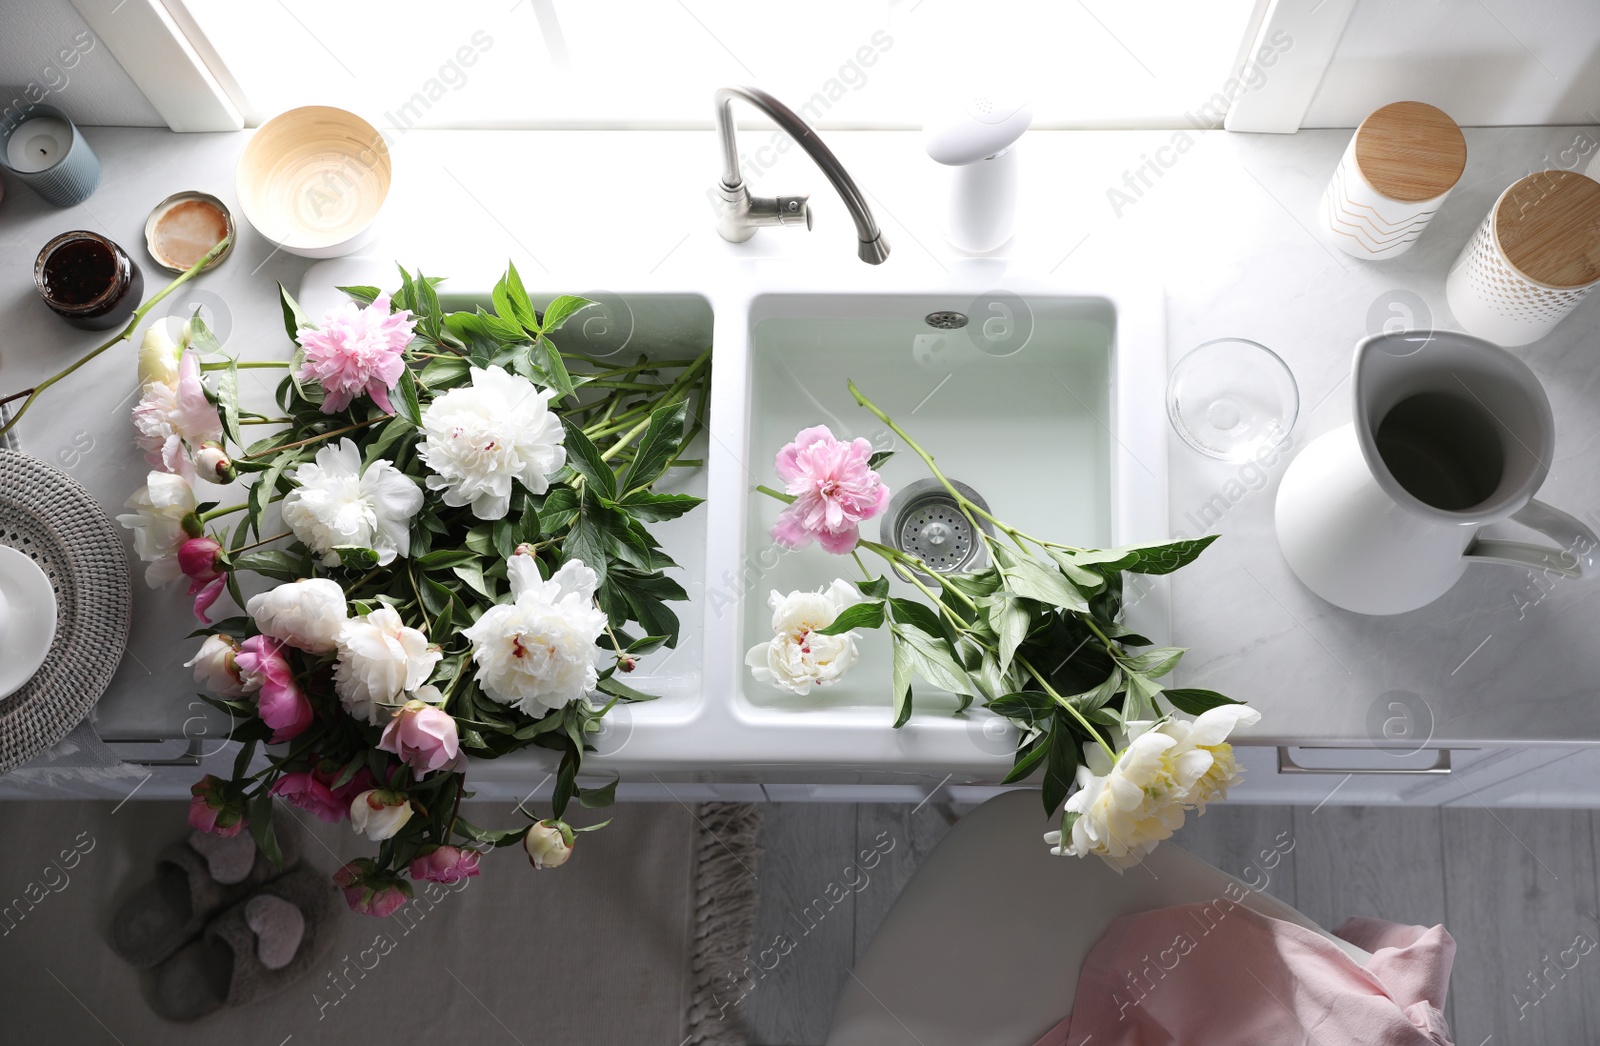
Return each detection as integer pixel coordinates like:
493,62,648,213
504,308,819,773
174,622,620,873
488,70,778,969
1322,102,1467,259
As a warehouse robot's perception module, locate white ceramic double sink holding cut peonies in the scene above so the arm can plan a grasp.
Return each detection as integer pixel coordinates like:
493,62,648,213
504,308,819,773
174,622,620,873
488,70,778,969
301,259,1168,782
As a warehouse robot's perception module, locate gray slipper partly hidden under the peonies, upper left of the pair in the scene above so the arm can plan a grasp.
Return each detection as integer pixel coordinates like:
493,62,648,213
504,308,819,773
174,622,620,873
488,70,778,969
110,824,299,969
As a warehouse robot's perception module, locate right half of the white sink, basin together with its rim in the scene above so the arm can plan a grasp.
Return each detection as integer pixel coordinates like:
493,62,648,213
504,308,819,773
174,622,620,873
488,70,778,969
706,269,1170,781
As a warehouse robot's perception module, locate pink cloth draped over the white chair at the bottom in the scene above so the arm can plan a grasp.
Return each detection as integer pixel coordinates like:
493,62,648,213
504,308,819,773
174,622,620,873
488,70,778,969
1035,897,1456,1046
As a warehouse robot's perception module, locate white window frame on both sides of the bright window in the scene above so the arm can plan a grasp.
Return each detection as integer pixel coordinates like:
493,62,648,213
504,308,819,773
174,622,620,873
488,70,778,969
81,0,1357,134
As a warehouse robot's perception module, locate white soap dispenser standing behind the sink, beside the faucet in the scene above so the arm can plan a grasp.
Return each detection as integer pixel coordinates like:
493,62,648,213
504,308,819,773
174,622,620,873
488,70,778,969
923,93,1034,254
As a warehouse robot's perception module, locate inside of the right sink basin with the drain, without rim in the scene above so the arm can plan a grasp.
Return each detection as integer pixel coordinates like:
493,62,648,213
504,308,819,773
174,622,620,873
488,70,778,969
738,296,1115,715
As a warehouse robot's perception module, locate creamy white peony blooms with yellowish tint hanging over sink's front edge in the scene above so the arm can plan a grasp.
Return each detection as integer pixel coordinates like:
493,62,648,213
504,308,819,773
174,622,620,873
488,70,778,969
1045,705,1261,872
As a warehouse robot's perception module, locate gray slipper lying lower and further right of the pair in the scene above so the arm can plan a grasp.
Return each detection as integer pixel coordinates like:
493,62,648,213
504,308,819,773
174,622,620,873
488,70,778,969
149,867,341,1020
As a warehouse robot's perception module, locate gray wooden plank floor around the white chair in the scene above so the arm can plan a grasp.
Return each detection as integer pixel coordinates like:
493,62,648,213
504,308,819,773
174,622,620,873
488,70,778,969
744,801,1600,1046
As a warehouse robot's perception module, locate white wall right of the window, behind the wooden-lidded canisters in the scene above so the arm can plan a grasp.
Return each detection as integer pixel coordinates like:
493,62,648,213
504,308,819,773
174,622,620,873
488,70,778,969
1304,0,1600,126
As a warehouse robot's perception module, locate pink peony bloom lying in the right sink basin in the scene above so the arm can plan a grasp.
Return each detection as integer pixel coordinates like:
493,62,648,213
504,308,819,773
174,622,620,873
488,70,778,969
773,425,890,555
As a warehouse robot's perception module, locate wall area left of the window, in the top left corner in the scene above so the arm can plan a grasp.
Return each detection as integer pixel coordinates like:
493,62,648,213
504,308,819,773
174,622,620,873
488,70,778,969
0,0,166,126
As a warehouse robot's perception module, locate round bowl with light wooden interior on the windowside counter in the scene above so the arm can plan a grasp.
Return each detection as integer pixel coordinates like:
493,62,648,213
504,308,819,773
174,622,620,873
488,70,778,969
234,106,392,258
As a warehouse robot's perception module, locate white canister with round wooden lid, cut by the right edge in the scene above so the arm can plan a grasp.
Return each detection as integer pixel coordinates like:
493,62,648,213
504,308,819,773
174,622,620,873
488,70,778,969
1445,171,1600,345
